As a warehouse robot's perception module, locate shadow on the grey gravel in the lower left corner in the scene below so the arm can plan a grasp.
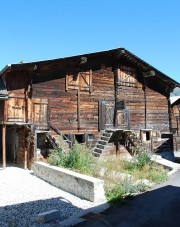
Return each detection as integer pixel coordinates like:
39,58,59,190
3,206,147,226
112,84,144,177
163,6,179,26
0,197,82,227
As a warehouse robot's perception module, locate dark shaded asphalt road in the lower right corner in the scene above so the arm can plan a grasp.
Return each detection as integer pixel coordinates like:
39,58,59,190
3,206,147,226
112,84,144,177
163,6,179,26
76,185,180,227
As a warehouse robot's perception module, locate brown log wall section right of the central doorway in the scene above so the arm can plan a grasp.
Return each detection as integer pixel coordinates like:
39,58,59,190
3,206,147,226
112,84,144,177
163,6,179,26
118,79,169,131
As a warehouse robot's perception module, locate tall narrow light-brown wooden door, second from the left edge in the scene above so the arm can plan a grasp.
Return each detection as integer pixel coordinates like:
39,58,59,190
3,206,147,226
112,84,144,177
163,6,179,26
33,99,49,130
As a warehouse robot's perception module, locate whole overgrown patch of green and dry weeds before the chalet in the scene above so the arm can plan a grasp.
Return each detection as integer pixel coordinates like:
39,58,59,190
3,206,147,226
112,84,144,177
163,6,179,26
48,145,168,205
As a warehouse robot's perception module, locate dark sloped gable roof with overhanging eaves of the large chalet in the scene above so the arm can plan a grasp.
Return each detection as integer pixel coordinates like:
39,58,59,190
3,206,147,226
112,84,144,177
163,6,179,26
0,48,180,88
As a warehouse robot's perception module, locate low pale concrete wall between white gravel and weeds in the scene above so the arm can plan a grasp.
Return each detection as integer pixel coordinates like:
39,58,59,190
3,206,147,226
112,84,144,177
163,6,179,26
32,162,106,203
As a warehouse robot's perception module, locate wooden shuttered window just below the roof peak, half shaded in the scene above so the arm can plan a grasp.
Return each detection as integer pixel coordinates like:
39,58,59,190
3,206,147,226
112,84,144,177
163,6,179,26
118,66,137,87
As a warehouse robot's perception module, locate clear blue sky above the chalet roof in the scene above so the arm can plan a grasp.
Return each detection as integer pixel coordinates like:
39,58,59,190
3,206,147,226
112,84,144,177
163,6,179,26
0,0,180,82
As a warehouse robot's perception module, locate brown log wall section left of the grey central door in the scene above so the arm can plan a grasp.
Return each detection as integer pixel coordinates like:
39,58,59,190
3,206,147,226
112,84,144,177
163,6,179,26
33,67,114,134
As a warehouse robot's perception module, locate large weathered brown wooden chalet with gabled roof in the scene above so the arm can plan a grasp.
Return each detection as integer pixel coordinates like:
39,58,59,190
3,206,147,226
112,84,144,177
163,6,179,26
0,48,179,168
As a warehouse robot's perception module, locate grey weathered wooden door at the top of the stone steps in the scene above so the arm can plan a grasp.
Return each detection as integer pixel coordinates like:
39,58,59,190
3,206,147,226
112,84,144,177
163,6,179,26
99,100,114,130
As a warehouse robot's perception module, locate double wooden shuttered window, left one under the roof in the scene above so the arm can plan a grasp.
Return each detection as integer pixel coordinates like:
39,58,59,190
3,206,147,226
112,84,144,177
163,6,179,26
66,70,92,93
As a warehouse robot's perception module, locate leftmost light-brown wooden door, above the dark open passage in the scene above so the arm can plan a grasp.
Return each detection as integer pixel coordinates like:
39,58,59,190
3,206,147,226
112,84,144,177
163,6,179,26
6,97,26,122
